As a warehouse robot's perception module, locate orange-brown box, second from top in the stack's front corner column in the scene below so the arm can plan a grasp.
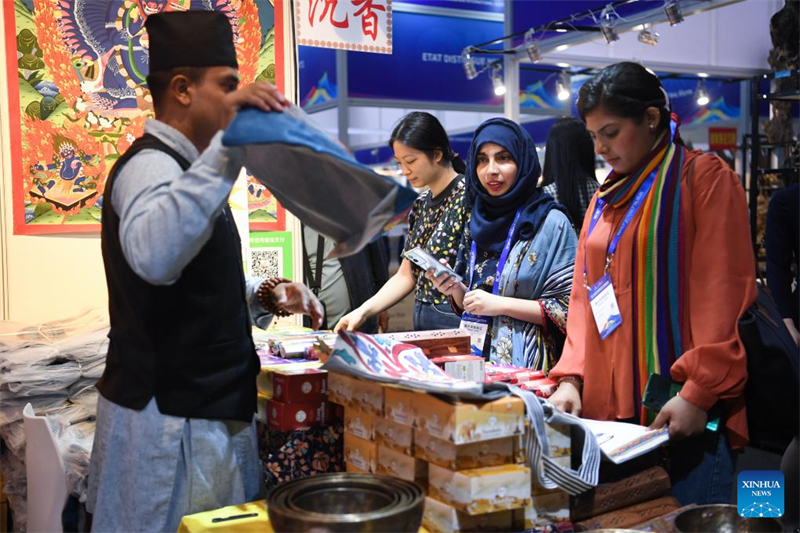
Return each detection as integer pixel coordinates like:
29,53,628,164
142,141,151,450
414,431,517,470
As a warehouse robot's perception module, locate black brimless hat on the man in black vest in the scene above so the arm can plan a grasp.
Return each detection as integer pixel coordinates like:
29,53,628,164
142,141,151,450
145,11,239,73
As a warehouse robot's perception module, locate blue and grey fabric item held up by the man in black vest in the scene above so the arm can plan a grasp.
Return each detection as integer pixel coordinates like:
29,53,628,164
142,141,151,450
222,107,417,257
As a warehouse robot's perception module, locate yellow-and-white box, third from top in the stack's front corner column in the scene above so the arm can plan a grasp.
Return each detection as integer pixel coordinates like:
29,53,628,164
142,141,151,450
428,463,531,515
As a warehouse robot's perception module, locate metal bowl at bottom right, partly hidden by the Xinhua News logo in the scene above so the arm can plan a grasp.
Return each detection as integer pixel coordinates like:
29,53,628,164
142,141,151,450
675,505,783,533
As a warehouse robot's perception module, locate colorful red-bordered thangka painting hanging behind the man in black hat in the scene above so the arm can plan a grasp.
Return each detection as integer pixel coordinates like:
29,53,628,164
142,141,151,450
3,0,282,234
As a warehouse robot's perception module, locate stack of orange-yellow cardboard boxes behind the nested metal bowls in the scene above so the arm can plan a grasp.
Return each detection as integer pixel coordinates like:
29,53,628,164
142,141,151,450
328,372,571,532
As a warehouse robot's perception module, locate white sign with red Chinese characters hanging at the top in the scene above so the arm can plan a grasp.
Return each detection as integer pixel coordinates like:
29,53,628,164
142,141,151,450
294,0,392,54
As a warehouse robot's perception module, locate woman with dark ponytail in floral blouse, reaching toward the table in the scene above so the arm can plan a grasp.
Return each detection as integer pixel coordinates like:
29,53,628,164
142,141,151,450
334,112,468,331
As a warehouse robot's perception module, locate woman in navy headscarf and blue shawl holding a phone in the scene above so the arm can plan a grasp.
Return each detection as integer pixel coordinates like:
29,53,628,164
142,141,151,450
426,118,577,371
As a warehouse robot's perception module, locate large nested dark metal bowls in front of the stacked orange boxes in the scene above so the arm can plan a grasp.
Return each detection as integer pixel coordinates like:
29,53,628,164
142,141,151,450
267,474,425,533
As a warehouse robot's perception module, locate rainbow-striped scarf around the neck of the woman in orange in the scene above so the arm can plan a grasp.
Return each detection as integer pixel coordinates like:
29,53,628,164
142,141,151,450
597,130,686,424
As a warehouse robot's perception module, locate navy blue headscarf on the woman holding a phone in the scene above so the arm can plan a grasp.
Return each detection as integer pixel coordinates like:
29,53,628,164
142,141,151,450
467,118,566,254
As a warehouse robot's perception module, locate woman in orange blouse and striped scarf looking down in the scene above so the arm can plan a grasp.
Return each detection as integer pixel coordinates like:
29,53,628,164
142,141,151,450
550,63,756,504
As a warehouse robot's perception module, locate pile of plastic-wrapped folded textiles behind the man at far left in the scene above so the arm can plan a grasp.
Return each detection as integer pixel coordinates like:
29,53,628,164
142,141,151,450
0,311,108,528
